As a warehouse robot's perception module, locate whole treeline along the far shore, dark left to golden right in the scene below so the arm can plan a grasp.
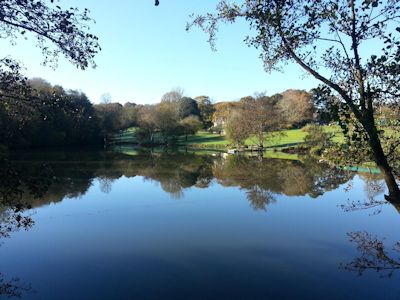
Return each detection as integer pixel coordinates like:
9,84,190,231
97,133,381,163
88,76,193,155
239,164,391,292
0,78,399,148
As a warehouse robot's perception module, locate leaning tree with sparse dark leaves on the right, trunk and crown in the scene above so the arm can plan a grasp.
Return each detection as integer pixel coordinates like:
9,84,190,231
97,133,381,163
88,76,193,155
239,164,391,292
188,0,400,201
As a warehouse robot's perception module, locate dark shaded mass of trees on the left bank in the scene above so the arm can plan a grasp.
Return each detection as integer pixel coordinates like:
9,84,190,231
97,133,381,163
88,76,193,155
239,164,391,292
0,78,99,148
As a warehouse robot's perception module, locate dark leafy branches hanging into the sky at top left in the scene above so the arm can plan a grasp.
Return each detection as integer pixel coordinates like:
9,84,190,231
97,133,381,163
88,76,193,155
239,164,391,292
0,0,100,69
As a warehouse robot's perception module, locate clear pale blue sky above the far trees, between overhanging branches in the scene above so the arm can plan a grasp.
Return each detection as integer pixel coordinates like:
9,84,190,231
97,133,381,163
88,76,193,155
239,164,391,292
0,0,318,103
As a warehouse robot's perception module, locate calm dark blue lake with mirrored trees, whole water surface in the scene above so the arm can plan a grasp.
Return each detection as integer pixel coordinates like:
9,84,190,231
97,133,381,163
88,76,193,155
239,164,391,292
0,151,400,299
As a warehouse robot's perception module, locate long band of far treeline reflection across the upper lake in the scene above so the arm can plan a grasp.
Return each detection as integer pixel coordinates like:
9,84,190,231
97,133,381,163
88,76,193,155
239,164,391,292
4,152,354,209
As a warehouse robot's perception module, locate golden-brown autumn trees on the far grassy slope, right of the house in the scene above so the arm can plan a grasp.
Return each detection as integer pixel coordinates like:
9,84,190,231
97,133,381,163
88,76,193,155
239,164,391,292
213,90,316,148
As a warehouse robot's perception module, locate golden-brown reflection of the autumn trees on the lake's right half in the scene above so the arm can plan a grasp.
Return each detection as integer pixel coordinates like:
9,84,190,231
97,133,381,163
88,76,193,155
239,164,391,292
213,156,354,198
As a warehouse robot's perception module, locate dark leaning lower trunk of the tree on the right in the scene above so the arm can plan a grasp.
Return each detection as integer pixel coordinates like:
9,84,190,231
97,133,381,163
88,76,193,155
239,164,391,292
364,119,400,203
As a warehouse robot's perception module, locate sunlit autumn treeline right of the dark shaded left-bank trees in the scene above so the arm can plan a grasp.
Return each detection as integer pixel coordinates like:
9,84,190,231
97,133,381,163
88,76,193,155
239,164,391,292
101,88,400,148
